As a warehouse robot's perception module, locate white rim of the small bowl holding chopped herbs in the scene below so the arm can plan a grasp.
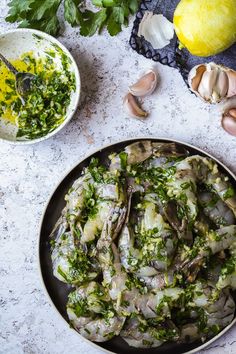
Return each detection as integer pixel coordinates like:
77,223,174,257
0,28,81,145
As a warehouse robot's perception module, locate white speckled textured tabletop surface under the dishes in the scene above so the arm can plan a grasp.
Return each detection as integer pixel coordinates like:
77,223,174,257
0,0,236,354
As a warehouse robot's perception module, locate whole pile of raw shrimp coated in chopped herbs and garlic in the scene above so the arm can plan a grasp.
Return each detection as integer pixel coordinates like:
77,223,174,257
50,140,236,348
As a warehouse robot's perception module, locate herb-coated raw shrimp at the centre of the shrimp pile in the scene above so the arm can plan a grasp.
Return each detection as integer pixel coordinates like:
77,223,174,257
118,188,177,277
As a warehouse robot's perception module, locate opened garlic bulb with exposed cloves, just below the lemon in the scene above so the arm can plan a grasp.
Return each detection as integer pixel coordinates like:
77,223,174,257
188,63,236,103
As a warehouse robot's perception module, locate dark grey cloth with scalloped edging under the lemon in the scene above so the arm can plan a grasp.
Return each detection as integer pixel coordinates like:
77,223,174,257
130,0,236,83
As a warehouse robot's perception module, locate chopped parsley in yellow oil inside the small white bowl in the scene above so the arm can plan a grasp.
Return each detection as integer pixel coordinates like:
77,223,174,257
0,52,76,140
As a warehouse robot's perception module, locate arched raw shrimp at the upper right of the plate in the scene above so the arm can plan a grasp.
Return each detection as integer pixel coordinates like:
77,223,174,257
166,155,236,239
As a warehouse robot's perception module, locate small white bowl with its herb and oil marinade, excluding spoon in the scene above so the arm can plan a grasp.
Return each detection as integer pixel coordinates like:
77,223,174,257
0,30,80,143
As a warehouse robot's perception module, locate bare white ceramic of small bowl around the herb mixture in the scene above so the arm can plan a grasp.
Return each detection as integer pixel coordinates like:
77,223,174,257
0,28,81,144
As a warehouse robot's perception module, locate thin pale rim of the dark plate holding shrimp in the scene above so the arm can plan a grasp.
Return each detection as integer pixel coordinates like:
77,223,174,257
37,136,236,354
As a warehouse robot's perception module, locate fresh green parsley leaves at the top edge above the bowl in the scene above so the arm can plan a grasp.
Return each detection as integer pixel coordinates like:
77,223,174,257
6,0,140,36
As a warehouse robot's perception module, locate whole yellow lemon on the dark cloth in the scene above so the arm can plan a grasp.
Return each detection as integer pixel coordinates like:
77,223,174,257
174,0,236,57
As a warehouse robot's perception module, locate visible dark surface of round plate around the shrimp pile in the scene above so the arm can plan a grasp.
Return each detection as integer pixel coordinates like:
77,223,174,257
39,138,236,354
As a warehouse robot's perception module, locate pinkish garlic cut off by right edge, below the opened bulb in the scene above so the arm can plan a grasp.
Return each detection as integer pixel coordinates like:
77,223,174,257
221,97,236,136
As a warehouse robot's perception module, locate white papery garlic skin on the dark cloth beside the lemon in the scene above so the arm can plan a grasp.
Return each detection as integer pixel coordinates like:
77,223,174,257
138,11,174,49
